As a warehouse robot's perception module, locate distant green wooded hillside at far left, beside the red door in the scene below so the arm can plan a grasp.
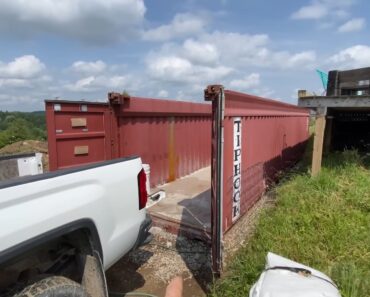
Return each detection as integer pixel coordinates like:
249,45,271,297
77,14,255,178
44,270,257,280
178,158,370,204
0,111,46,148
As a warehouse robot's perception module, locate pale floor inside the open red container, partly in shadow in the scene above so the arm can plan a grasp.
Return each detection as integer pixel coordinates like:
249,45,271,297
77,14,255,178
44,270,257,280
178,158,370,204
149,167,211,239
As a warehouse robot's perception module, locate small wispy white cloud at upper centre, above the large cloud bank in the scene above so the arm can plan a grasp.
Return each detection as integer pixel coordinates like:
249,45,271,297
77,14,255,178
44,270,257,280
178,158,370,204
143,13,206,41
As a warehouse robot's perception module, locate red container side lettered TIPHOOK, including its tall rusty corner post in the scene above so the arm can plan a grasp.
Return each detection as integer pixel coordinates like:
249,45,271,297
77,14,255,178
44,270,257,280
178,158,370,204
205,85,309,273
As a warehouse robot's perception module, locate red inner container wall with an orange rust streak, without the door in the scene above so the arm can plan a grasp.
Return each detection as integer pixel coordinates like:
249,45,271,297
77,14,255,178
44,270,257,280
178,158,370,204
115,97,211,186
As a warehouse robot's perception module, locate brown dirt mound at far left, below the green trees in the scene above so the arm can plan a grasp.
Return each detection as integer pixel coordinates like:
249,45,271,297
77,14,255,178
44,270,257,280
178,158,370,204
0,140,49,172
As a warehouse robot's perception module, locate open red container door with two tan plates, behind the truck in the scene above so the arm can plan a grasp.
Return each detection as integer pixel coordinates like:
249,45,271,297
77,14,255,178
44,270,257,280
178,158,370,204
45,100,112,170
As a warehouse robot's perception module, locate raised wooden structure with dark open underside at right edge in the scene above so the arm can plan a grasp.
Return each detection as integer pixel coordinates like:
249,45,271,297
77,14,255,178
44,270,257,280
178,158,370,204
298,67,370,175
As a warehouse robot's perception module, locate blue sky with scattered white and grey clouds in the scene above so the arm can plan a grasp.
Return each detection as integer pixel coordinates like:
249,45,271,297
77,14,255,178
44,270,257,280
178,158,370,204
0,0,370,111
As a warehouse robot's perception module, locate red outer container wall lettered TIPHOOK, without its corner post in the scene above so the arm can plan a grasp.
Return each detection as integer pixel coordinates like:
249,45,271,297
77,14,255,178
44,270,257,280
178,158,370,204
223,90,309,231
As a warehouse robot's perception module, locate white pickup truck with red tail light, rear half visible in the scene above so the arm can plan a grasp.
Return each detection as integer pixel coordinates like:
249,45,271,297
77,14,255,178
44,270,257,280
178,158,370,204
0,157,151,297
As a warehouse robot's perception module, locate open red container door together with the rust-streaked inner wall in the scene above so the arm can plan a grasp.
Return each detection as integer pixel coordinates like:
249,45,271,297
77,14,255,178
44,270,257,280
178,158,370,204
46,93,211,186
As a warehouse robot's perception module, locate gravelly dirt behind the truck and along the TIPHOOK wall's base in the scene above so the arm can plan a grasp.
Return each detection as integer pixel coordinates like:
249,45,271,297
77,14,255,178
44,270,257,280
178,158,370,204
107,195,273,297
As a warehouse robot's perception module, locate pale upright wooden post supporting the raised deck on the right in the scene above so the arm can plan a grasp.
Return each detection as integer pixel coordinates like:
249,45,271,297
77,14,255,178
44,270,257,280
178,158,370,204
311,108,326,176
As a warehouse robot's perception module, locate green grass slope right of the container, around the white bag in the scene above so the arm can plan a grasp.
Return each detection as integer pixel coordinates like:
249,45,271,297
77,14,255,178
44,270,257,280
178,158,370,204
210,151,370,297
